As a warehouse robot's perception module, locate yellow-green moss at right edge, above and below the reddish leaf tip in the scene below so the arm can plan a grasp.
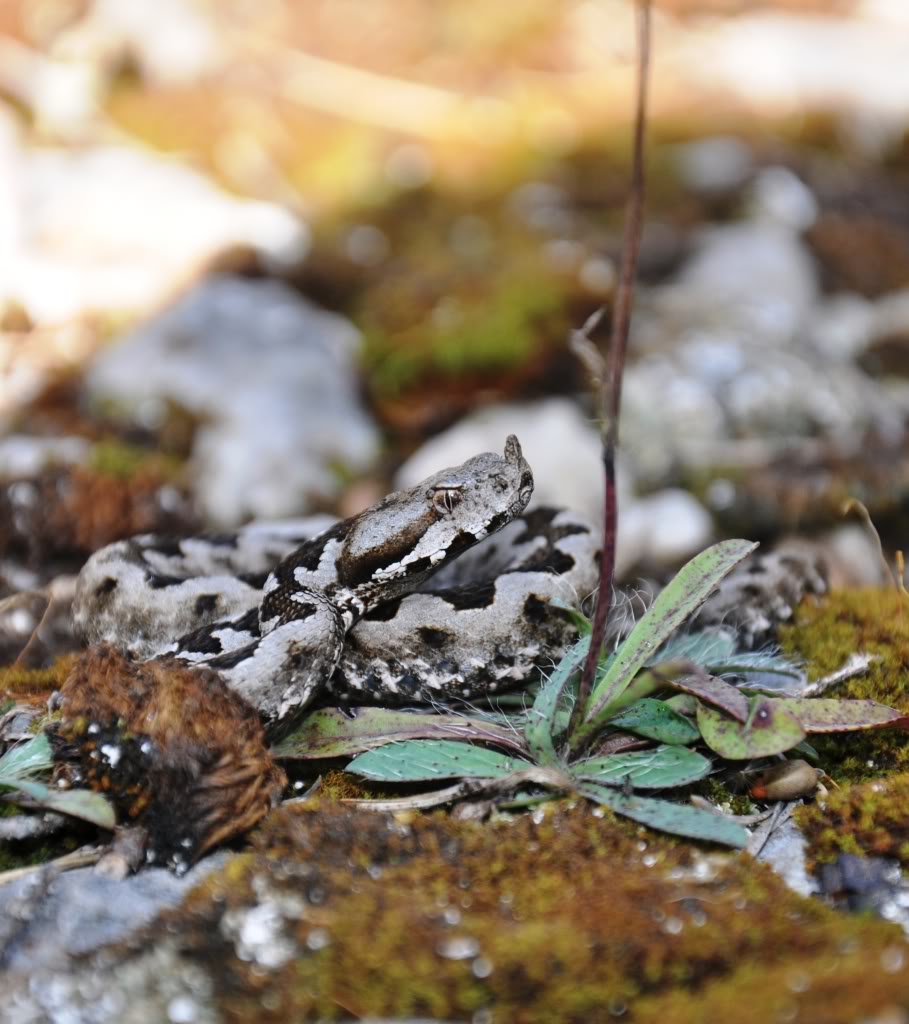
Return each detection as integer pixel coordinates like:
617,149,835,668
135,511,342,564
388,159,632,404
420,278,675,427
780,589,909,781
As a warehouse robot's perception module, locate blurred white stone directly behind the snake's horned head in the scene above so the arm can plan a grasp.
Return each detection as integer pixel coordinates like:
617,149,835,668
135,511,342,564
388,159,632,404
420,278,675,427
394,398,632,540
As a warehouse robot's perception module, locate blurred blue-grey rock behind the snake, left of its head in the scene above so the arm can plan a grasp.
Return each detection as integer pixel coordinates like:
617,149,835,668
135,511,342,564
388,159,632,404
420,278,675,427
86,274,378,526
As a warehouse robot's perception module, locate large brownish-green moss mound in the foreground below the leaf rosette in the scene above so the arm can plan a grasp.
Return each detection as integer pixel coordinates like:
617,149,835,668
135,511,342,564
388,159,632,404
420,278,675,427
81,801,909,1024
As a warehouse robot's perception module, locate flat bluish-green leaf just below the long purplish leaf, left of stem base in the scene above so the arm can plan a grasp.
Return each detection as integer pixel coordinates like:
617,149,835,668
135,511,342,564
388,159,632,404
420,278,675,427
347,739,532,782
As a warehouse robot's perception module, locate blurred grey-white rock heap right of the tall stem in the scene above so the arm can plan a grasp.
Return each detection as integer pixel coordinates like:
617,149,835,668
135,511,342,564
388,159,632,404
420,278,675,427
622,199,909,486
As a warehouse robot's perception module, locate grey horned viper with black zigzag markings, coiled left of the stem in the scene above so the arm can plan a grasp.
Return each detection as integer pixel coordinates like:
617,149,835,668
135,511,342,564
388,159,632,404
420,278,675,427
73,435,599,731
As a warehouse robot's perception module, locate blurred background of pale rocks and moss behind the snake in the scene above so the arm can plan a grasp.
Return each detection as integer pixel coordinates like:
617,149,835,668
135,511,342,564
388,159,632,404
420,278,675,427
0,0,909,593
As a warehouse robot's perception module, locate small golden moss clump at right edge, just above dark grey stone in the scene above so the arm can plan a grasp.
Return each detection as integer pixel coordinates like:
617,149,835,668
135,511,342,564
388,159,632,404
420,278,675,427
796,773,909,866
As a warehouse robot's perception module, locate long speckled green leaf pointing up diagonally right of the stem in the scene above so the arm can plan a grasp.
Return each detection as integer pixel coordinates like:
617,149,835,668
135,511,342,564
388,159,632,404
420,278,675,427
572,541,758,749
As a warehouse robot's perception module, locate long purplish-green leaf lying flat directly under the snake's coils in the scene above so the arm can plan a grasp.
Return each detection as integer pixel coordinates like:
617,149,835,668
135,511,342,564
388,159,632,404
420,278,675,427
271,708,525,761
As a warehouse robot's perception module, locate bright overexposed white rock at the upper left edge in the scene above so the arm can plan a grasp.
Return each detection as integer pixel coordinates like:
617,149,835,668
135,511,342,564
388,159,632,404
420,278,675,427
0,121,308,326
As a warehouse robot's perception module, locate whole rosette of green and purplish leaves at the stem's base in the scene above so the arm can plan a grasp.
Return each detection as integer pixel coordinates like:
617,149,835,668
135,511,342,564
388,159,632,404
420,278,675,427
274,541,906,847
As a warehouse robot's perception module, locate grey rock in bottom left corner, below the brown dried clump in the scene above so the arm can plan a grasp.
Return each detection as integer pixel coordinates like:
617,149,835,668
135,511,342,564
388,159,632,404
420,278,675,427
0,853,229,971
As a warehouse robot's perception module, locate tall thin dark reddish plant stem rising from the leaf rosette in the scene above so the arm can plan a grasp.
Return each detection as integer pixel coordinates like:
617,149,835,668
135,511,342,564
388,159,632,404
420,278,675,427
572,0,650,727
